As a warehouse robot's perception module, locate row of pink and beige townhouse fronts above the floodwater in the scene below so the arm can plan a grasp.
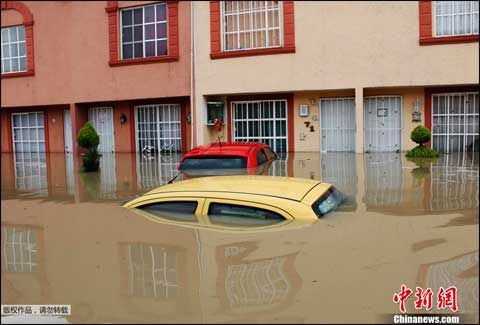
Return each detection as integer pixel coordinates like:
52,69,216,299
1,1,480,157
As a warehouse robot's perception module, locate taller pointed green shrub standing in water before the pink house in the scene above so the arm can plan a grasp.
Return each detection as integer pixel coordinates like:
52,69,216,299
77,122,102,172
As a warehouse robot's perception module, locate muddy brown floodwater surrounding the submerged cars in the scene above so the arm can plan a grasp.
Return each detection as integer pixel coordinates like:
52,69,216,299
1,153,479,324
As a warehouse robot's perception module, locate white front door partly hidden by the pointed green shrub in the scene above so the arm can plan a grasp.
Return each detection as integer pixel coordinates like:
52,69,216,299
88,107,115,152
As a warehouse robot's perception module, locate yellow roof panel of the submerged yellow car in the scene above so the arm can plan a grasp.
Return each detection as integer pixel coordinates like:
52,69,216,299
145,175,321,201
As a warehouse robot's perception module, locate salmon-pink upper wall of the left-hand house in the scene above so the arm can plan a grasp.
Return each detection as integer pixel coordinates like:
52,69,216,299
1,1,191,107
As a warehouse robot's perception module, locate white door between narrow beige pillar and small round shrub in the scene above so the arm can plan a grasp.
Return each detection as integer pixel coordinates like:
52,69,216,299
364,96,403,152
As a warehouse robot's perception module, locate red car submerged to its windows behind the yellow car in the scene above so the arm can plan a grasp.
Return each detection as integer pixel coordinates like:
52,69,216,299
178,142,277,171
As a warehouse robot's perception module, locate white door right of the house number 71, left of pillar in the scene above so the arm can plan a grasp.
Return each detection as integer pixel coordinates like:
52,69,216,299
320,98,355,151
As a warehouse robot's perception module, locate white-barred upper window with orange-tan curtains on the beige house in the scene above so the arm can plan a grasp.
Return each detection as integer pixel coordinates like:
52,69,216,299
221,1,283,51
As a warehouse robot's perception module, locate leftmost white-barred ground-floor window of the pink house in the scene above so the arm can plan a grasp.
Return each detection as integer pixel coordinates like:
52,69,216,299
12,112,45,152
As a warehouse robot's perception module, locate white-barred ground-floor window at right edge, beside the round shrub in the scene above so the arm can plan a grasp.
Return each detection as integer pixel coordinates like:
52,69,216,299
432,92,480,153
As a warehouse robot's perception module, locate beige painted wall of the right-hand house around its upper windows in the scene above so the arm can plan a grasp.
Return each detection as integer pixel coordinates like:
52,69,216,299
193,1,479,146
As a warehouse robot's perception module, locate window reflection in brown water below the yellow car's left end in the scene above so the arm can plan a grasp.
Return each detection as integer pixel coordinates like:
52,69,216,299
127,244,178,299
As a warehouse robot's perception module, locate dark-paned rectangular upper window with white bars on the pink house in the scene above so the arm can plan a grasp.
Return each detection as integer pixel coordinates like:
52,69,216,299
120,3,168,59
